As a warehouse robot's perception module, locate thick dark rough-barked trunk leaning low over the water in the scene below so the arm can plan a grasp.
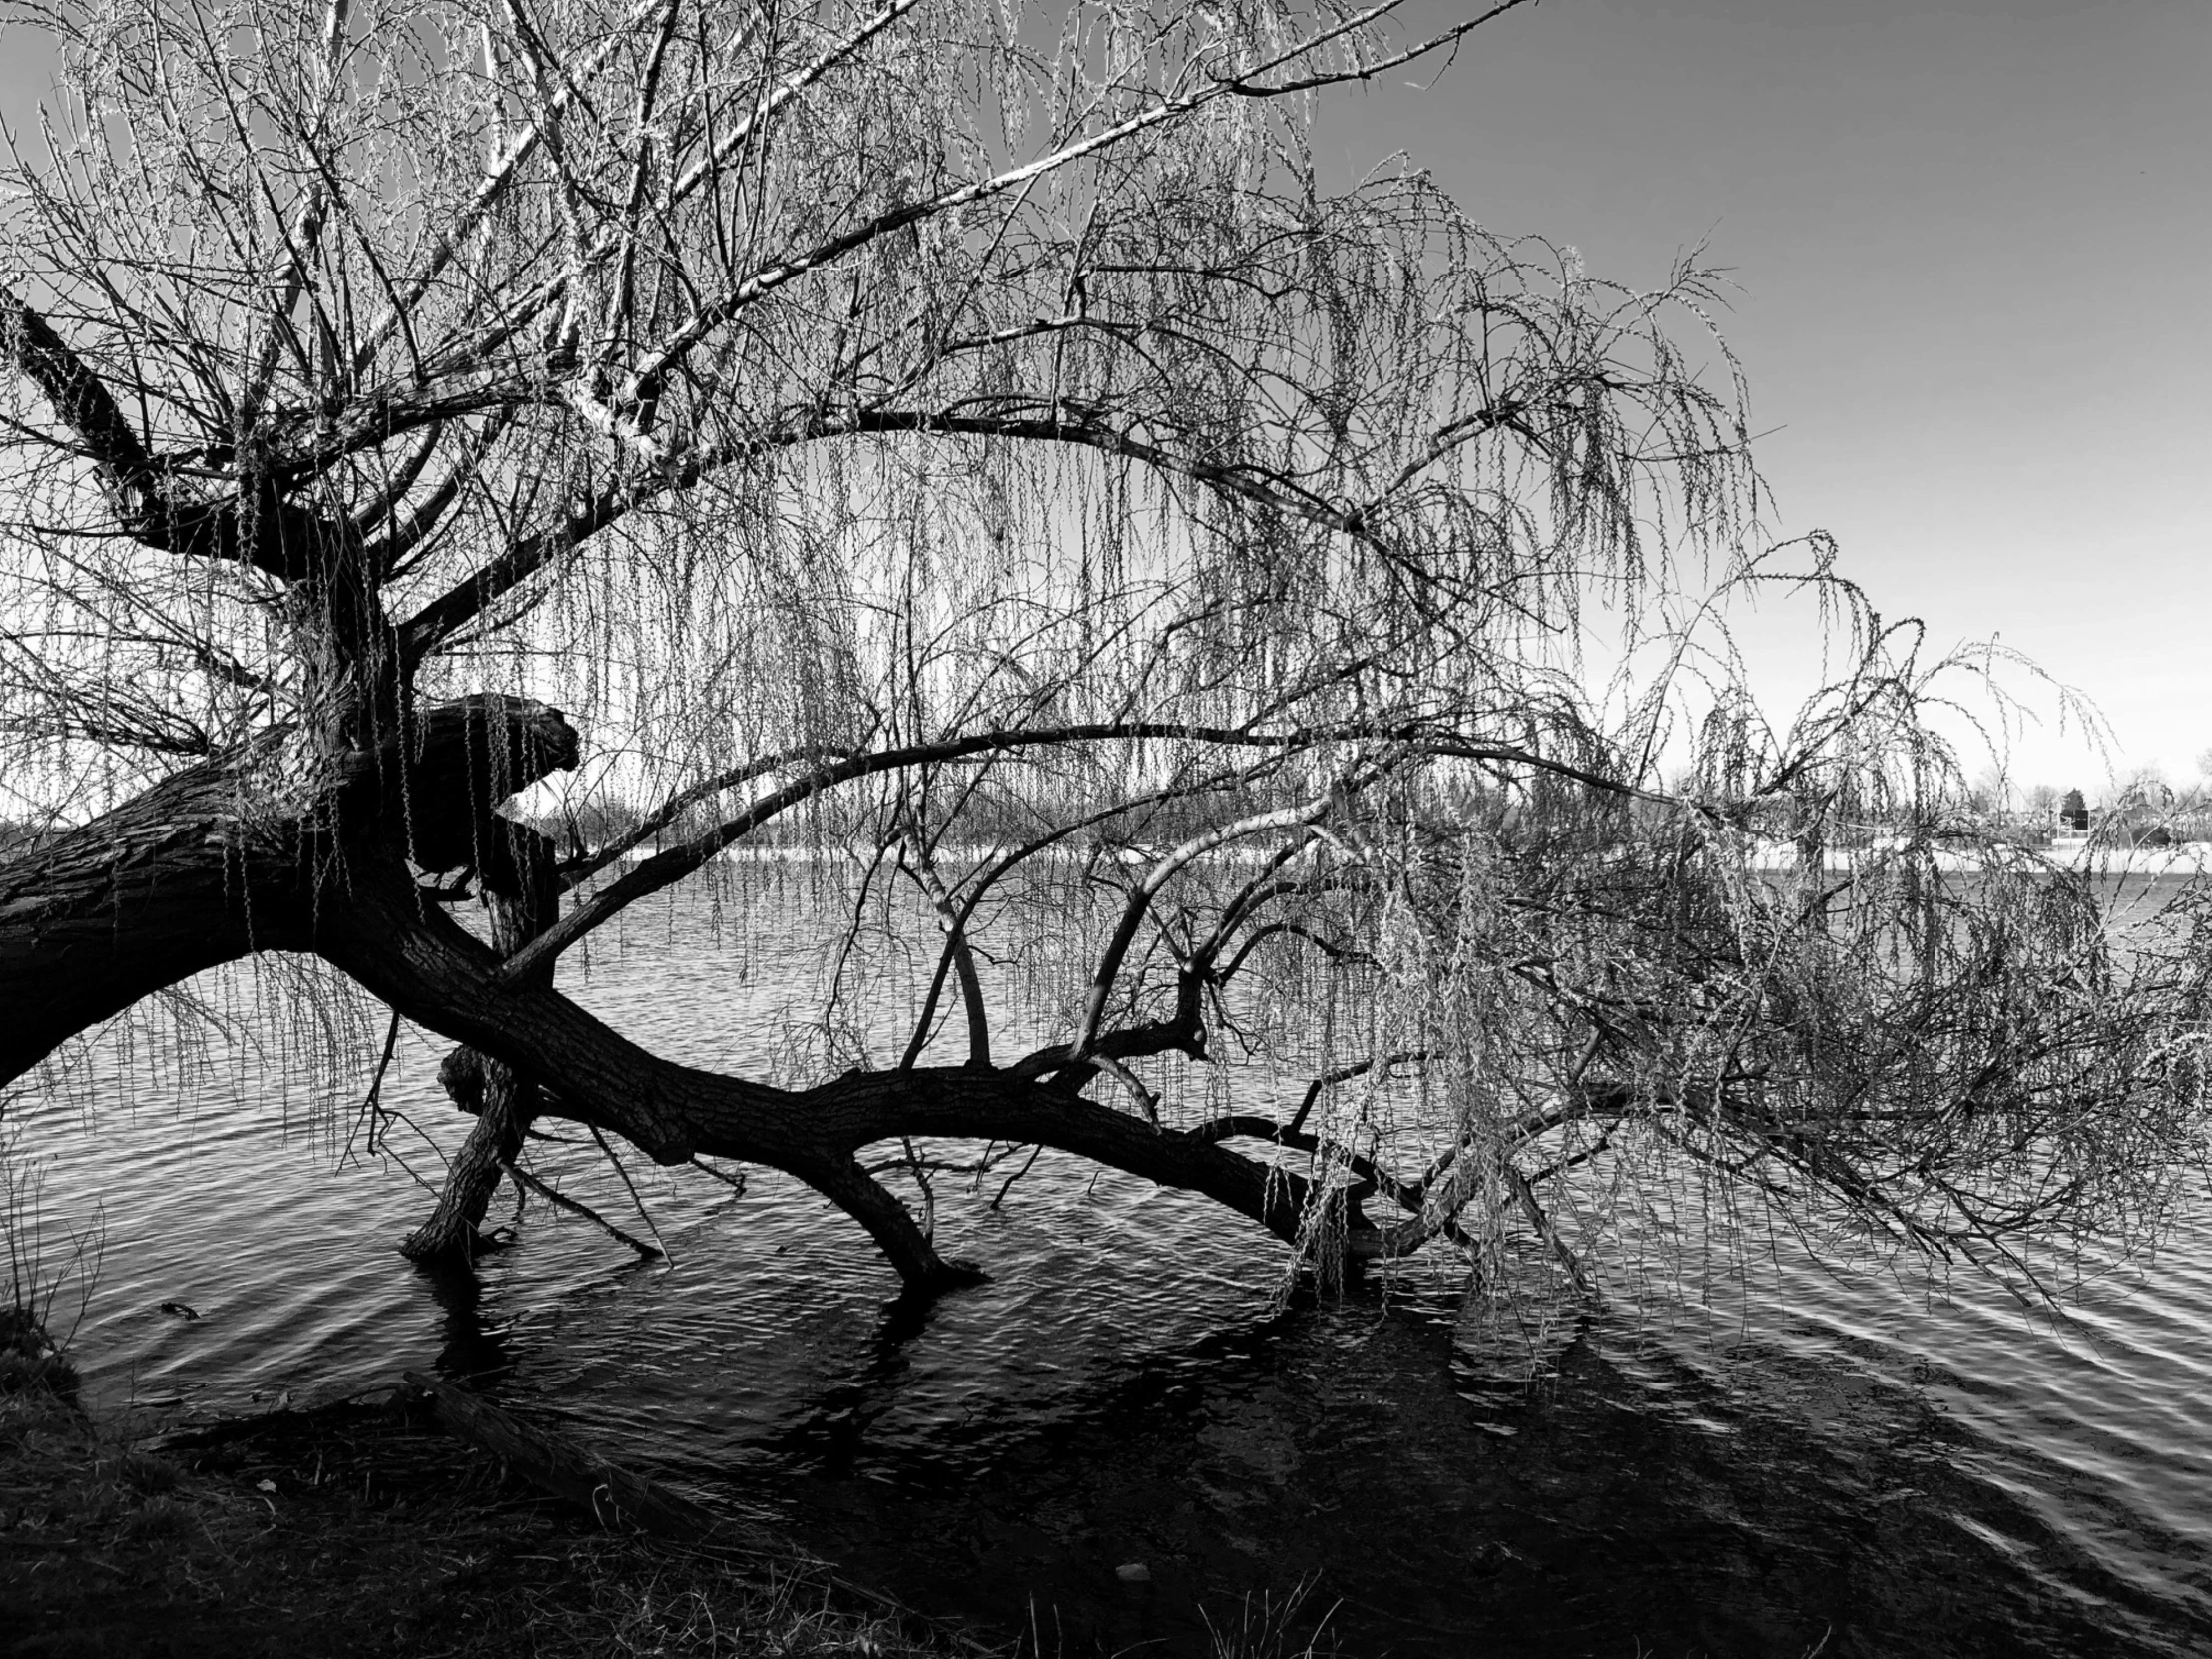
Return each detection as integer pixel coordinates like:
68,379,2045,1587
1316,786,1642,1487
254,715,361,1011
0,697,1380,1292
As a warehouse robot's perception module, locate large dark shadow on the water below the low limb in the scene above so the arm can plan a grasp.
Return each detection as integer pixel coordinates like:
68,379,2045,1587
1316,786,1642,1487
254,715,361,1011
721,1290,2196,1657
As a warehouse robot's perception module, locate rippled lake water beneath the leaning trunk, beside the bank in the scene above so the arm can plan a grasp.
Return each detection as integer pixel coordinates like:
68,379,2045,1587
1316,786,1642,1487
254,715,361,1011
11,888,2212,1659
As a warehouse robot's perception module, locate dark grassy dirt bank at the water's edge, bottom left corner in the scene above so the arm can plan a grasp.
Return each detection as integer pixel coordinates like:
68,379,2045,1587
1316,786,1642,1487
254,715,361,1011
0,1391,984,1659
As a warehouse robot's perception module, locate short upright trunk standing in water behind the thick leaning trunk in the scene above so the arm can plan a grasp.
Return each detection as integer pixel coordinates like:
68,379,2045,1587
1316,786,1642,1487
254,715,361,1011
400,819,560,1263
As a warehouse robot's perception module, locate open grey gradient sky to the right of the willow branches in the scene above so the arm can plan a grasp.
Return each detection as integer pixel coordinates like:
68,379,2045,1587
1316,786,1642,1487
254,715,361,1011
1323,0,2212,786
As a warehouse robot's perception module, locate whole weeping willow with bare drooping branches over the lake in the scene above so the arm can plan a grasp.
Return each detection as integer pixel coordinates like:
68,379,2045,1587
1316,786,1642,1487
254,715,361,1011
0,0,2201,1288
